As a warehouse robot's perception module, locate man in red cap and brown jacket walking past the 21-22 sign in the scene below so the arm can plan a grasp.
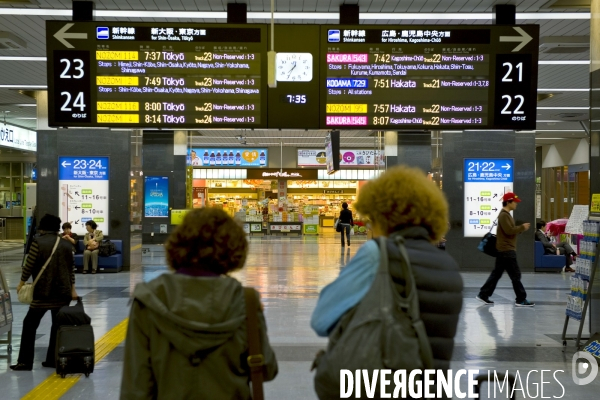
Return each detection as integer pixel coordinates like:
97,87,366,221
476,192,535,307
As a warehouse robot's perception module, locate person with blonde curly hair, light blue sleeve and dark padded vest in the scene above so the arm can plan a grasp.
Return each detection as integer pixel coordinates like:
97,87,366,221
311,166,463,382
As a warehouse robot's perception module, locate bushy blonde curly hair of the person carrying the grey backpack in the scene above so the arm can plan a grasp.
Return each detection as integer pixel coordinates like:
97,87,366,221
354,166,448,242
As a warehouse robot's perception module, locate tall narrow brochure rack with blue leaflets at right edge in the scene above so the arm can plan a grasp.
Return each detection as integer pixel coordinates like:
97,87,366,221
562,221,600,350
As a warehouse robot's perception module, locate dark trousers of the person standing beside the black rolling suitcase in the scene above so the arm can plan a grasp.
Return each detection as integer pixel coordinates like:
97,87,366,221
18,304,66,365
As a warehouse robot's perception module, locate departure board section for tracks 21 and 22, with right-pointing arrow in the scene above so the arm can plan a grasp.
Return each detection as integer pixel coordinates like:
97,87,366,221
320,25,539,130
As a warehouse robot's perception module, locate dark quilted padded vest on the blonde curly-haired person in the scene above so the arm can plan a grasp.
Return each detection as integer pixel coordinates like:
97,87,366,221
388,227,463,370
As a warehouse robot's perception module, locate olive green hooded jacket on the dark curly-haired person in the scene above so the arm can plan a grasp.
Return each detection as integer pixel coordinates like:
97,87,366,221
121,274,277,400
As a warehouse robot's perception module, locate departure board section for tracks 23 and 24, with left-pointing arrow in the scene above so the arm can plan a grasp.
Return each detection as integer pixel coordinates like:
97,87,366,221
46,21,267,129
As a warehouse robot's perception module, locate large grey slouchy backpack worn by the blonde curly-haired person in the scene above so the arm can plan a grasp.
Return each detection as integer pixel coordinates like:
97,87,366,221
313,235,434,400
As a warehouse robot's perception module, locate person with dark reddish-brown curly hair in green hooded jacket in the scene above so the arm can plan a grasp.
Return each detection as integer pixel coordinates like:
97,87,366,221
121,208,277,400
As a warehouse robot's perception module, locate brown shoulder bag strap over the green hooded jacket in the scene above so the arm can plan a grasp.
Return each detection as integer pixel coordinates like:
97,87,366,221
244,288,265,400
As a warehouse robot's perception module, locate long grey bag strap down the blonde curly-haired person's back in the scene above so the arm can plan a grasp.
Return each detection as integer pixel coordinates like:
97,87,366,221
379,235,434,369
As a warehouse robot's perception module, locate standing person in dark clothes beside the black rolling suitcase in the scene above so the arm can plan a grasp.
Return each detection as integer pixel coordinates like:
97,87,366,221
10,214,77,371
